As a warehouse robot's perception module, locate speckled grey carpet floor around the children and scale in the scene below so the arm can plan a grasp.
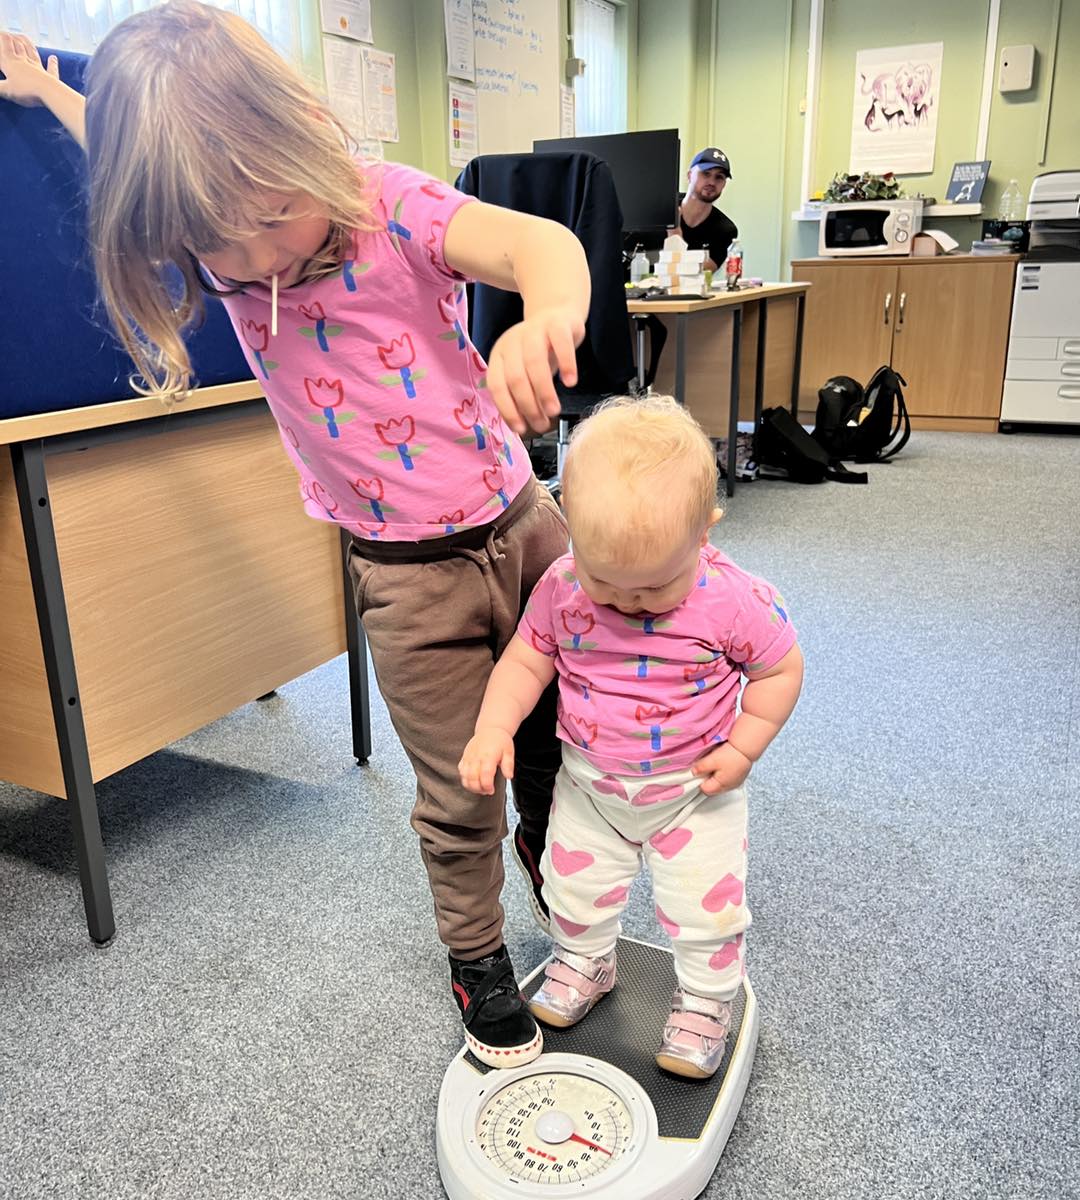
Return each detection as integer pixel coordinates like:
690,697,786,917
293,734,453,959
0,433,1080,1200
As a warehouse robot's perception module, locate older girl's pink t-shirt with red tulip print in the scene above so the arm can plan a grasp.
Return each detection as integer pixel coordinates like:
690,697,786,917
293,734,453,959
224,163,532,541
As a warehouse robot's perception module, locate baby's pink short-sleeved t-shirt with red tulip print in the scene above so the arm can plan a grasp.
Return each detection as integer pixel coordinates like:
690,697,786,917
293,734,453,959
517,546,796,776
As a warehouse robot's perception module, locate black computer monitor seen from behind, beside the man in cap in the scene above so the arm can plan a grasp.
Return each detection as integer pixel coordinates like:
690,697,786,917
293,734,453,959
533,130,679,250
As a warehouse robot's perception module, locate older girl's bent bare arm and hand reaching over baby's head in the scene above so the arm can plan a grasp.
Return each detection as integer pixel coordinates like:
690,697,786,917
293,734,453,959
443,203,592,433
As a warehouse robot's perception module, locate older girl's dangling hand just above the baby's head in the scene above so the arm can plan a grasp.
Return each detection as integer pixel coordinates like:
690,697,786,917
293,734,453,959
487,306,584,433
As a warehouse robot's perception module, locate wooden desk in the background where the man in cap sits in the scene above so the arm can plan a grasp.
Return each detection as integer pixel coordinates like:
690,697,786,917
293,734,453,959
626,283,810,496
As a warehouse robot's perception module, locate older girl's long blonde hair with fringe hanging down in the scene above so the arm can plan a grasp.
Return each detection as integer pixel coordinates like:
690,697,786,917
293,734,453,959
86,0,371,395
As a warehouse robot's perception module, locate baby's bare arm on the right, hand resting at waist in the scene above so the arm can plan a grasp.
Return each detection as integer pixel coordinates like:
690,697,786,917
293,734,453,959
692,646,803,796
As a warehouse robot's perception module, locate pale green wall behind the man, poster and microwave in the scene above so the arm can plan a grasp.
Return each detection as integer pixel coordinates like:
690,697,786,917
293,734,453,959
632,0,1080,278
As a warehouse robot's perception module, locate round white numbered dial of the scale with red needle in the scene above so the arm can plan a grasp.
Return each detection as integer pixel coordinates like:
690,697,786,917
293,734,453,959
476,1070,634,1187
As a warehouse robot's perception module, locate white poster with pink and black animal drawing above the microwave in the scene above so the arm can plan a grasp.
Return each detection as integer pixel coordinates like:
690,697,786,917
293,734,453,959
851,42,944,175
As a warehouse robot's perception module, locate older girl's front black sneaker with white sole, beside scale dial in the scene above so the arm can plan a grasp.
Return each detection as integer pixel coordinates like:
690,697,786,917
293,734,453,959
450,946,544,1067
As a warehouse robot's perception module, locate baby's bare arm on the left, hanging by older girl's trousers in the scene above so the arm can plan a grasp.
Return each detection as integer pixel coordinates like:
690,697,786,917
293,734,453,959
457,634,556,796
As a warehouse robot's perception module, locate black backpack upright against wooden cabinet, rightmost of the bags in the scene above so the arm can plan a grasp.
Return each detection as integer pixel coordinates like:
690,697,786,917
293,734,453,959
811,367,911,462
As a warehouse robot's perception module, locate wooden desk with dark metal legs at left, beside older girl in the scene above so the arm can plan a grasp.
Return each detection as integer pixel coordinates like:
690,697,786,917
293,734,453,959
0,382,371,943
